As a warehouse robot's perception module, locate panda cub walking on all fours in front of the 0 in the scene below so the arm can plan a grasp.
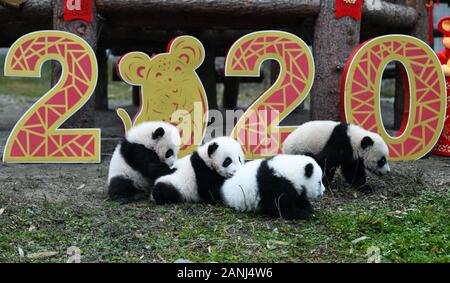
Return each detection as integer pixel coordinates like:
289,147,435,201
283,121,390,193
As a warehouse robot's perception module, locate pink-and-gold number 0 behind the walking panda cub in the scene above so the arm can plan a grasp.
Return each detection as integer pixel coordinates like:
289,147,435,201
341,35,447,160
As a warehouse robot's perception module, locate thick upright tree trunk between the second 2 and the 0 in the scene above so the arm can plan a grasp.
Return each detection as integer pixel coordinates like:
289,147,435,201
311,0,360,121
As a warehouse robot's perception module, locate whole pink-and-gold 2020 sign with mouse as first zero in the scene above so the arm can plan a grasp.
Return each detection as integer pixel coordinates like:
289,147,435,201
3,30,446,163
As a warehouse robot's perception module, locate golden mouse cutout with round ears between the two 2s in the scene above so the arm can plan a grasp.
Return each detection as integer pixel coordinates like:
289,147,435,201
117,36,208,157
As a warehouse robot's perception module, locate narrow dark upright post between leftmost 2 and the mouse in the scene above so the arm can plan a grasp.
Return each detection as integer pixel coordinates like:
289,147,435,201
95,48,108,110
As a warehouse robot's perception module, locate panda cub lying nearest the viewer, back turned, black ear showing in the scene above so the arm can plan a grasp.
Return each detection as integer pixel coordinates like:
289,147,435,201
221,154,325,219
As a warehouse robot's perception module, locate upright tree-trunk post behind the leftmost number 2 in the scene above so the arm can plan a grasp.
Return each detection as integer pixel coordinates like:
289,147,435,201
52,0,98,128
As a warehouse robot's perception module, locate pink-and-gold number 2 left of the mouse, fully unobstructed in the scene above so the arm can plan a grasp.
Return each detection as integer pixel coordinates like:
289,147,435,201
3,31,100,163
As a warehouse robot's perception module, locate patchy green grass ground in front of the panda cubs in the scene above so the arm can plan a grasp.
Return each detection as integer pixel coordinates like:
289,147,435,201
0,188,450,262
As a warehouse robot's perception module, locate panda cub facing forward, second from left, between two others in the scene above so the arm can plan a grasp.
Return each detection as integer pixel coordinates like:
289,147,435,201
152,137,245,204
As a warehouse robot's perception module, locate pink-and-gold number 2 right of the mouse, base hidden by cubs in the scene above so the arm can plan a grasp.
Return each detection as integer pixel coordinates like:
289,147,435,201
225,31,314,159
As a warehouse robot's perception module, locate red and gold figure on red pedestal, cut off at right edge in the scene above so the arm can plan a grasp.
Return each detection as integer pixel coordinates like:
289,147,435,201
432,17,450,156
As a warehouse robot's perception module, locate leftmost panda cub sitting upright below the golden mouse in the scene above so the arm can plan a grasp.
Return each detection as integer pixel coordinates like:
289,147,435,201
108,122,180,203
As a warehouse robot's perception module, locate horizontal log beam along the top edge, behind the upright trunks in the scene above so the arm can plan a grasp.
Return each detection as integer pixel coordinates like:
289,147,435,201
0,0,419,27
